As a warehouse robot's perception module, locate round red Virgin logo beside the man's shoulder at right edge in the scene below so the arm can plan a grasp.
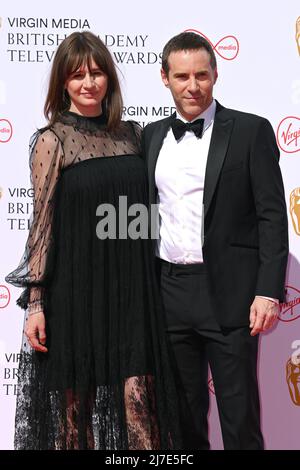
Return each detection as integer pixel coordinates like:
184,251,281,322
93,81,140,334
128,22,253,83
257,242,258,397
277,116,300,153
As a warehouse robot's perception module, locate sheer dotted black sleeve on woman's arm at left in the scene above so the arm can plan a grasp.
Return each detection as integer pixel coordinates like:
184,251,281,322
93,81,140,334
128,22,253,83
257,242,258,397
6,129,64,313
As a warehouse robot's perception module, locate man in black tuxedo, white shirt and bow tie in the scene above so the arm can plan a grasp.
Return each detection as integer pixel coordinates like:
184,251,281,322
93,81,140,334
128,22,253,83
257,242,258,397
143,33,288,450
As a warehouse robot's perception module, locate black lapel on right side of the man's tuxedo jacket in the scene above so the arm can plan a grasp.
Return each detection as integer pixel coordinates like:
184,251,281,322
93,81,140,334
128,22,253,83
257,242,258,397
203,103,233,215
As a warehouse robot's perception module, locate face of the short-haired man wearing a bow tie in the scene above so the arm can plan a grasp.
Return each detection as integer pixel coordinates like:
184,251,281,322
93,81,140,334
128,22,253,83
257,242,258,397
161,49,218,121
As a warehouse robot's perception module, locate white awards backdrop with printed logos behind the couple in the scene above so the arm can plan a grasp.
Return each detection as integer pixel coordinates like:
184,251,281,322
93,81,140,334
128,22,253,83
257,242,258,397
0,0,300,449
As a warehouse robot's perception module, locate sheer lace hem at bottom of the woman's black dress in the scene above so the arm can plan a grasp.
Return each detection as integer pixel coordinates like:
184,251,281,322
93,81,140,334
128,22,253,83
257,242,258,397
15,352,173,450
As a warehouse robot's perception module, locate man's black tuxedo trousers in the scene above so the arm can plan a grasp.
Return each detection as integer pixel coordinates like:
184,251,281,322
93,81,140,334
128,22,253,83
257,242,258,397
158,260,263,450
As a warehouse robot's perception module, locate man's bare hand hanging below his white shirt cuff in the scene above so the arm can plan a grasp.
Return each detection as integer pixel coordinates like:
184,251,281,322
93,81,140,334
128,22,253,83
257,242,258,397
250,296,279,336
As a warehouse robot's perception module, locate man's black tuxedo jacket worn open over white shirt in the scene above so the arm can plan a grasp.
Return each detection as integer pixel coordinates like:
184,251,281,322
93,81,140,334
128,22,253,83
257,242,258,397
143,103,288,328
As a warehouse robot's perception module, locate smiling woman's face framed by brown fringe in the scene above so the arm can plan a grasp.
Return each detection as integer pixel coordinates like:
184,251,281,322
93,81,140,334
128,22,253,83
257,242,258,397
65,60,107,116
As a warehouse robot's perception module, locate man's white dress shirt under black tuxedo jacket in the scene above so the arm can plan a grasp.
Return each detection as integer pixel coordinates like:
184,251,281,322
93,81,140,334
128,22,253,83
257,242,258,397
155,100,216,264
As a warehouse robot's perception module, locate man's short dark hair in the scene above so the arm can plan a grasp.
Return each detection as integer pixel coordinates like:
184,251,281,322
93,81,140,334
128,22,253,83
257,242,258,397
161,32,217,76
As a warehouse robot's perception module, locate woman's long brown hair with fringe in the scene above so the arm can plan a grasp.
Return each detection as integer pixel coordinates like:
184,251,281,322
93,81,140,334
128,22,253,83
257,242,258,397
44,31,123,129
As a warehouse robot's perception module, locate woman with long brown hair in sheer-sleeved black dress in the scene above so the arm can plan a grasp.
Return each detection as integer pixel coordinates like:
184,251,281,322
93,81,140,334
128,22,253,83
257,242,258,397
7,32,180,450
